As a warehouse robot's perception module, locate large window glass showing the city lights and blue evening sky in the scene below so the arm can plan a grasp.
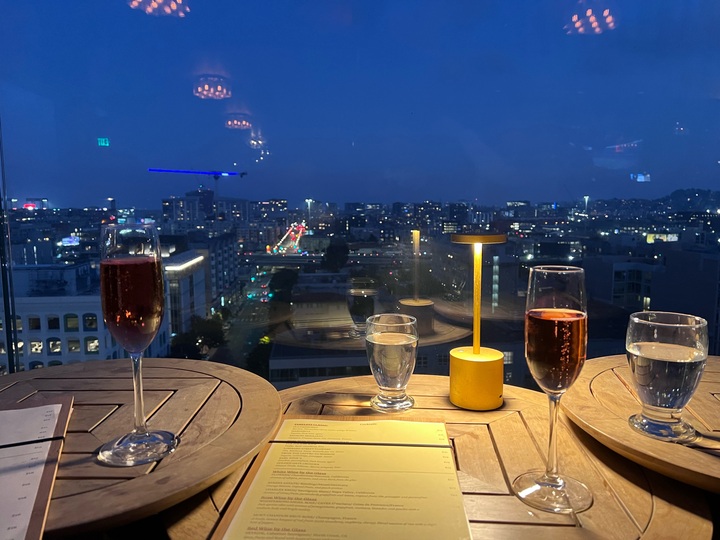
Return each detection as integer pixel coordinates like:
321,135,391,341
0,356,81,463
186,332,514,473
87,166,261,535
0,4,720,386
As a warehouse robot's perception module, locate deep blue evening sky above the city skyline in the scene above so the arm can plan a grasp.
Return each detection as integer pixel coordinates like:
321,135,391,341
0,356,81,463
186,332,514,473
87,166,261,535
0,0,720,208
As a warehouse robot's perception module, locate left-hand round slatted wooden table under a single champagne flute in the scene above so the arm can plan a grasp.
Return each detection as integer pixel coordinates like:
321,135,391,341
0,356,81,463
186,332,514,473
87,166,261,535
0,359,281,538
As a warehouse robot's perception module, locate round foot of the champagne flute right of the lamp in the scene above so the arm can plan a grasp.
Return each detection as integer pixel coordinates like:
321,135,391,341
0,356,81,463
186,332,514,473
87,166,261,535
512,470,593,514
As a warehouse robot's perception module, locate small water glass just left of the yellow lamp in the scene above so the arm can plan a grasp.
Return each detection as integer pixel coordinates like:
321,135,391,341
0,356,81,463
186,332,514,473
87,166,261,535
365,313,418,412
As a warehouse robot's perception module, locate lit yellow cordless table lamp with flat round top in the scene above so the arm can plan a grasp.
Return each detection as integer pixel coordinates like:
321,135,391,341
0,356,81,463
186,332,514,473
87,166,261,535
450,234,507,411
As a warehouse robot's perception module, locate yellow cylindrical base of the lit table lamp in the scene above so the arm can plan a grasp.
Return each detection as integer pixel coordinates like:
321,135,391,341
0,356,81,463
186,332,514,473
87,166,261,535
450,347,505,411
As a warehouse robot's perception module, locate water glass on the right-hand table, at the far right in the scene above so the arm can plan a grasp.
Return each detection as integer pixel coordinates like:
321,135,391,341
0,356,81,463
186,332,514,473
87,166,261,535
625,311,708,441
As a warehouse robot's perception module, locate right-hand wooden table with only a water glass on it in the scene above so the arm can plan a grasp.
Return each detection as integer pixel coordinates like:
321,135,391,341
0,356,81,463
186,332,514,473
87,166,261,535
563,354,720,493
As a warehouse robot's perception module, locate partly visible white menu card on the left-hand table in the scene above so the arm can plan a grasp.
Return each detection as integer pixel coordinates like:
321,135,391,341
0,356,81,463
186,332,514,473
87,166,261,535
0,396,73,540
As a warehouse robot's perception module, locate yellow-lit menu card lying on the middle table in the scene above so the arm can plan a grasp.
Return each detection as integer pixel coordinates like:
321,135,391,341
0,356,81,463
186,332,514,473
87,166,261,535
214,418,471,540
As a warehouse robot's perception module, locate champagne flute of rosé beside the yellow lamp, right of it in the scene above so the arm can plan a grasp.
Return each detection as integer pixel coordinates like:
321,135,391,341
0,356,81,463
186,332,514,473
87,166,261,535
512,266,592,513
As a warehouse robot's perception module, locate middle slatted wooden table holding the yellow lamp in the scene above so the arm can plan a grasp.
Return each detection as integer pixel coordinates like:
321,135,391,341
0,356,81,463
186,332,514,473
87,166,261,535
266,375,713,540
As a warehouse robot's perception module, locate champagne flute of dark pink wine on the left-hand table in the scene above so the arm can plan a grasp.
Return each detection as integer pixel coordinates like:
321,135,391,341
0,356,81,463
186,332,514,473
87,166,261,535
98,223,180,466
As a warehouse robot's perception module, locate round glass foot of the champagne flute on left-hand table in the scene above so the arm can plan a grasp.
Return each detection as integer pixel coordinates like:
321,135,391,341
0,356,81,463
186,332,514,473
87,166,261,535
98,431,180,467
